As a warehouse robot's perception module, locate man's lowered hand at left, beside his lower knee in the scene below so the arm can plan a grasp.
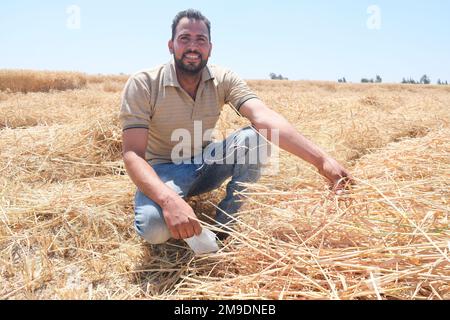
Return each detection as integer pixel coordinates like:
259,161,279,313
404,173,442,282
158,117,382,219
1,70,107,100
161,195,202,239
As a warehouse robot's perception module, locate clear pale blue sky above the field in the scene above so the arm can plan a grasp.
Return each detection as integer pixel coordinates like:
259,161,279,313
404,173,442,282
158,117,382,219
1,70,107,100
0,0,450,83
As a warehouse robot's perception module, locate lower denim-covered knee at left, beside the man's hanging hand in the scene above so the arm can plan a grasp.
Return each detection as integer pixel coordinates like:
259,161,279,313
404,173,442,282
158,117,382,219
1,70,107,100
135,204,170,244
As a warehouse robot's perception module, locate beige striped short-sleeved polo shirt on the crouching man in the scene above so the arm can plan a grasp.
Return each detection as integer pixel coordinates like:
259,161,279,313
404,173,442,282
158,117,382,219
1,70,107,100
119,58,257,165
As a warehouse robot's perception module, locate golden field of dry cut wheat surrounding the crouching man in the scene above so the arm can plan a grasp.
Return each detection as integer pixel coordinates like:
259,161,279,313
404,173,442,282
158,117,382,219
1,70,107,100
0,70,450,300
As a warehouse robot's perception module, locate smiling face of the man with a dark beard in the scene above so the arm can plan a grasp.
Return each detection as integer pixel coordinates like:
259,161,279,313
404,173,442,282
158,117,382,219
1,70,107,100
169,18,212,75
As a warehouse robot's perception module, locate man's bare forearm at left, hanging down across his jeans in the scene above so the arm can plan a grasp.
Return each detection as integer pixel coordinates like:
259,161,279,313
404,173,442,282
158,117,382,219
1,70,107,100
123,152,178,207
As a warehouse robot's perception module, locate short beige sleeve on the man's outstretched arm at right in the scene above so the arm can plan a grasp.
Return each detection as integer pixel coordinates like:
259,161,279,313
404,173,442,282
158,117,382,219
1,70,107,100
224,71,258,111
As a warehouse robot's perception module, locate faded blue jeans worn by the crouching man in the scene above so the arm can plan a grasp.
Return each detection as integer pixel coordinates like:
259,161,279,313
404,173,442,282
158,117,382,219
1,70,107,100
134,127,268,244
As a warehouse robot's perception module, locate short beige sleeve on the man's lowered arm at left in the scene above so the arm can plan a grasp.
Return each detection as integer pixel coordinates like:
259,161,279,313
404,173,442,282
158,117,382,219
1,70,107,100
119,73,152,130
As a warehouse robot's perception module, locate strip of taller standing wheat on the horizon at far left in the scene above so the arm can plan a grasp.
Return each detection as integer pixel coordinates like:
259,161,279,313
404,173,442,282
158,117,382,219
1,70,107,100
0,70,87,93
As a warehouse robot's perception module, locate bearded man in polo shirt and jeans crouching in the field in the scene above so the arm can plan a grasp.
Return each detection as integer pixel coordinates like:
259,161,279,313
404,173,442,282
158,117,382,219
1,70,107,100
120,9,350,244
